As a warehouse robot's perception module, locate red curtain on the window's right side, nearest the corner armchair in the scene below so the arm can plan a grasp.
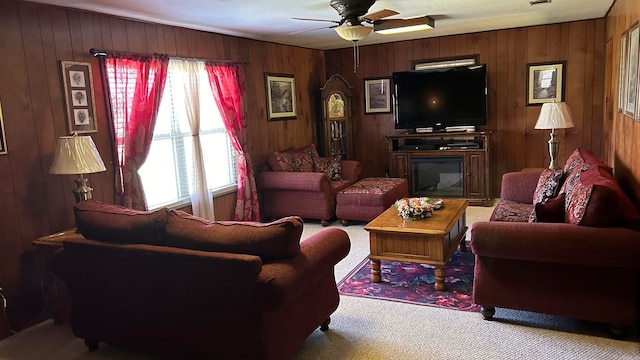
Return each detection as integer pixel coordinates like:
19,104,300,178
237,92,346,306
206,62,260,221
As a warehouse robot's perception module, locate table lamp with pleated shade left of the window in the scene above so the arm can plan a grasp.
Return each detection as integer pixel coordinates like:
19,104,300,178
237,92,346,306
49,135,107,203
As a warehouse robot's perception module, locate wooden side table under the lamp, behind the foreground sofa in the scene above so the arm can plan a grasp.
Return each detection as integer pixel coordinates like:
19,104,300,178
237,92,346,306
31,228,84,324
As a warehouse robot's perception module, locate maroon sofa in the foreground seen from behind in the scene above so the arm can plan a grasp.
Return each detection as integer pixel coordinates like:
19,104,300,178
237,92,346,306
53,200,350,359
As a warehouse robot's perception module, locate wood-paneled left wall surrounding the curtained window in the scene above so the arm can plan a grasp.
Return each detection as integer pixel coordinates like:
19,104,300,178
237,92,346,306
0,0,325,338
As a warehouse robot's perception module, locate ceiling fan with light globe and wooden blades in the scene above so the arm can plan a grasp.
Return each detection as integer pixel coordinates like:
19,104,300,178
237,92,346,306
291,0,434,41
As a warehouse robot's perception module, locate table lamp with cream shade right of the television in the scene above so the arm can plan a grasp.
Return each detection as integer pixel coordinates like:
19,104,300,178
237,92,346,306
535,102,573,170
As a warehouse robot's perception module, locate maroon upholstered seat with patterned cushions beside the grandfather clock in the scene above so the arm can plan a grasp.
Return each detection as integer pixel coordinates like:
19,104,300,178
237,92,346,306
256,144,362,226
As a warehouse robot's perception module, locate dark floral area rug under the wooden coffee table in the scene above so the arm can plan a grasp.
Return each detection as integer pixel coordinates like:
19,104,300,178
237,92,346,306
338,251,480,312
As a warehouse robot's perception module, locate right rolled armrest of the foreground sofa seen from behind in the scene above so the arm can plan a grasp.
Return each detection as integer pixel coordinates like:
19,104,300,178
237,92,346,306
258,228,351,307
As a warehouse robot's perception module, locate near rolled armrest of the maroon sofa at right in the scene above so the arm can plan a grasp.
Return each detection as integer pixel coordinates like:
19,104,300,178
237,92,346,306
471,221,640,269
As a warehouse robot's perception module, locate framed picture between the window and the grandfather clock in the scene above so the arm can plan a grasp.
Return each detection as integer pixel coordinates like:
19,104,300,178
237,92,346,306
264,73,297,121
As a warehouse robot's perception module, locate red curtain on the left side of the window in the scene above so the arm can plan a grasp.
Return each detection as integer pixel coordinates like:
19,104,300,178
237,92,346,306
104,53,169,210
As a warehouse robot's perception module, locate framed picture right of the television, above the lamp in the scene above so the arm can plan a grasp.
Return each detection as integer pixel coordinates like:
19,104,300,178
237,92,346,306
527,61,566,105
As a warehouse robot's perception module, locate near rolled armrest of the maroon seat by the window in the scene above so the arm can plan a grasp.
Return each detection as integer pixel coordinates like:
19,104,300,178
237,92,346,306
256,171,331,192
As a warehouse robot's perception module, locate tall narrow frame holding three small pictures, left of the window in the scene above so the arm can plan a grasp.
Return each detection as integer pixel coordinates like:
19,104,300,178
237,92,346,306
60,61,98,134
